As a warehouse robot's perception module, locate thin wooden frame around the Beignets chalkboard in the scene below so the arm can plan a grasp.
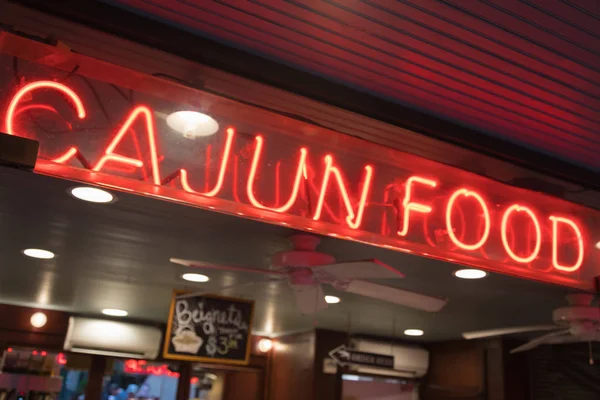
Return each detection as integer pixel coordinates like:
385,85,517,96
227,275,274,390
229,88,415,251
162,290,255,365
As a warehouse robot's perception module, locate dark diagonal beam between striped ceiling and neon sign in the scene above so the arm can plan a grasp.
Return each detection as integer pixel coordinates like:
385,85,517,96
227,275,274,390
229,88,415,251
9,0,600,190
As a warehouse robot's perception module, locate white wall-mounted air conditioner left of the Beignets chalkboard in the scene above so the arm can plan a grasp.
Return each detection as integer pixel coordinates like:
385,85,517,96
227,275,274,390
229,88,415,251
64,317,162,360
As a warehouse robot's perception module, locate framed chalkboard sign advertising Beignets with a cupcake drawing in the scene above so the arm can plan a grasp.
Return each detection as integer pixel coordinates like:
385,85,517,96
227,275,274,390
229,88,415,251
163,292,254,364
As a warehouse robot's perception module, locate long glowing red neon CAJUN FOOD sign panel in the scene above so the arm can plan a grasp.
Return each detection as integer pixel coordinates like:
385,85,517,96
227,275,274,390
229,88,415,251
0,35,600,289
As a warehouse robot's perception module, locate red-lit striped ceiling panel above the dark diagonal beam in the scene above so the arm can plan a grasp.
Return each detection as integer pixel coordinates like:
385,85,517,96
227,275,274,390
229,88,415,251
112,0,600,170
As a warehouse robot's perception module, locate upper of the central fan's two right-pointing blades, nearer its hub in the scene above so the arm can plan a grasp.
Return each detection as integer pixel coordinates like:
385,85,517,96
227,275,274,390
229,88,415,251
313,260,404,282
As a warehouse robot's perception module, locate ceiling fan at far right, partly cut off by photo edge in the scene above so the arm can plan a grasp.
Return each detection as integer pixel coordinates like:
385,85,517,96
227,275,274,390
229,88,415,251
463,293,600,354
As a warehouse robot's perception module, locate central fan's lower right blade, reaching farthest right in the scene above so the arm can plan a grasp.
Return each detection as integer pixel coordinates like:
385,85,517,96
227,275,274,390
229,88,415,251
333,280,447,312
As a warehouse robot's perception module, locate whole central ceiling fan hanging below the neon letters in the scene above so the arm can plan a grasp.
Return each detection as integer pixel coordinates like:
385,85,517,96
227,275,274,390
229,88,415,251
171,234,447,314
